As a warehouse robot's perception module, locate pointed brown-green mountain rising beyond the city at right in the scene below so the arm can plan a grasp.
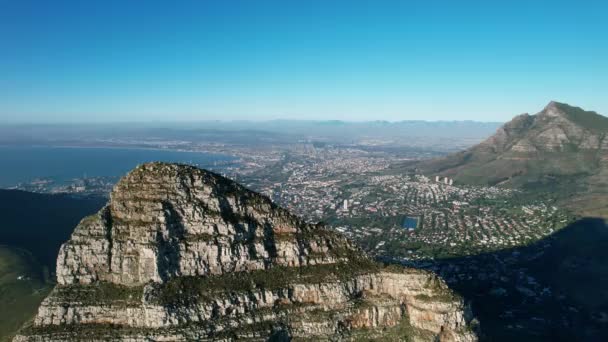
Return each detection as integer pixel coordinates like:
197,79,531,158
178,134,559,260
416,102,608,216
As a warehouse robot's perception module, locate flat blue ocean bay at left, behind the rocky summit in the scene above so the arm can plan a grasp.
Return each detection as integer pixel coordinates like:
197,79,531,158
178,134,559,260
0,147,236,188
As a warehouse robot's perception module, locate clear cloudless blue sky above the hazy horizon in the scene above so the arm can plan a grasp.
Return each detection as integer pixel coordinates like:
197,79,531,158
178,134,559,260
0,0,608,122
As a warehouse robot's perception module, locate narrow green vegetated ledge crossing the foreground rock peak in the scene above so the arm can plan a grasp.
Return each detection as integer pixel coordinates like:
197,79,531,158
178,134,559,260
46,258,380,307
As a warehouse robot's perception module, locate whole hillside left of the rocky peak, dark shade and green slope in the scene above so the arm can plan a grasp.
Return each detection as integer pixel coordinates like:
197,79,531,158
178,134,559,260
0,189,105,341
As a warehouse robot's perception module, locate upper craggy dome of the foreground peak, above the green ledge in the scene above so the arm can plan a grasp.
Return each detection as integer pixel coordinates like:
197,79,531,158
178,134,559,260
57,163,352,285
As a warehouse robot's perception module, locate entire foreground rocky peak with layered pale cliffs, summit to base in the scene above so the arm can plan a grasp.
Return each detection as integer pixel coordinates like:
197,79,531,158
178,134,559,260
15,163,477,341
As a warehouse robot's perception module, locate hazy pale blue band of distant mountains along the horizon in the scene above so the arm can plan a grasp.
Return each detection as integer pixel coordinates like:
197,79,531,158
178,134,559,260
0,120,500,151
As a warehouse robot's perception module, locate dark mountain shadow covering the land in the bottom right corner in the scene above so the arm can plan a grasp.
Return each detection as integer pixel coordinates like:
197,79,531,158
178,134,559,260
408,218,608,341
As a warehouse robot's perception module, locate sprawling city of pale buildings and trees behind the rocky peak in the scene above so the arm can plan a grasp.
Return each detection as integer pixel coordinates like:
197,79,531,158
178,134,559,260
8,144,573,265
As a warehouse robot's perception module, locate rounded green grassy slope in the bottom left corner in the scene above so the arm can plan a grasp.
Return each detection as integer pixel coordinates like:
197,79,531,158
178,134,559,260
0,245,52,342
